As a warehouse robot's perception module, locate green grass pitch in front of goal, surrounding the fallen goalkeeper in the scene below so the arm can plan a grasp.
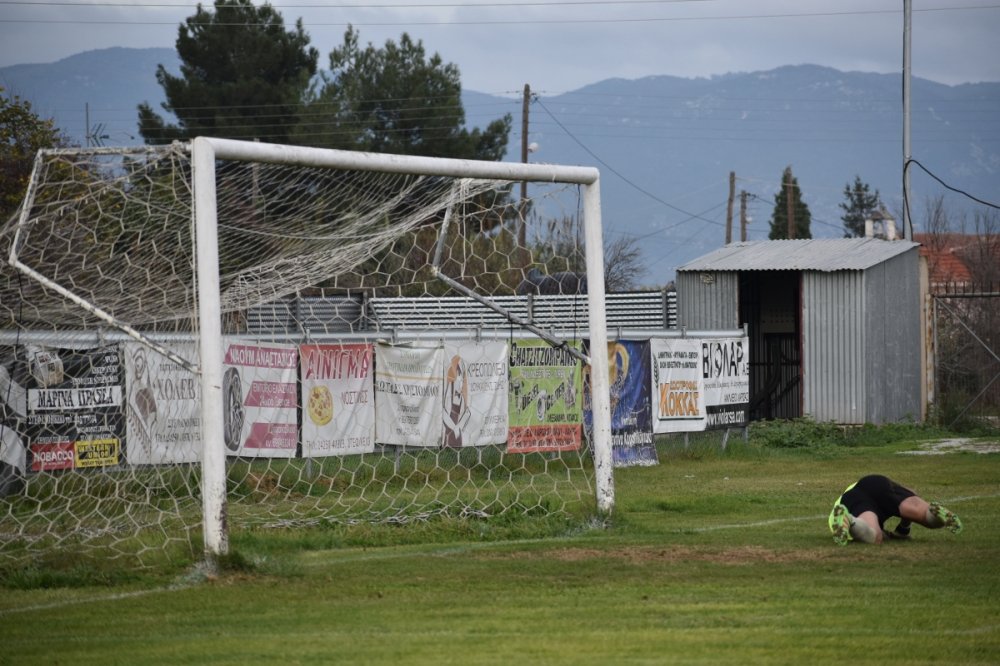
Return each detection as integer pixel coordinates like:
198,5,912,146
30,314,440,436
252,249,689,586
0,428,1000,664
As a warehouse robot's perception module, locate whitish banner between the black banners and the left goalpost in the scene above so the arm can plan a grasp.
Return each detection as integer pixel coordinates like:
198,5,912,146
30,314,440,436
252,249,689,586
122,342,202,465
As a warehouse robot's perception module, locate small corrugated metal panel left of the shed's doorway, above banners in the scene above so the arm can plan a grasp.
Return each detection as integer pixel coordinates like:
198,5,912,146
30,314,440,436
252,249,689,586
677,271,740,331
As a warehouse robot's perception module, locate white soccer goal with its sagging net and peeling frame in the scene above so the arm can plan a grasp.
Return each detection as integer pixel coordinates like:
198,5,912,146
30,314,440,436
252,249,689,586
0,138,614,559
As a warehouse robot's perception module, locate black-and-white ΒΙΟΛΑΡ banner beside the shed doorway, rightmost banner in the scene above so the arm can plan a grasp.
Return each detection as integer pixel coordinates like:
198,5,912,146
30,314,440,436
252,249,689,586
701,337,750,430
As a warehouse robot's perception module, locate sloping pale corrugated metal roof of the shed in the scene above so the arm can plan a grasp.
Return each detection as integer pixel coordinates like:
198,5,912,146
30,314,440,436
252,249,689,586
677,238,919,272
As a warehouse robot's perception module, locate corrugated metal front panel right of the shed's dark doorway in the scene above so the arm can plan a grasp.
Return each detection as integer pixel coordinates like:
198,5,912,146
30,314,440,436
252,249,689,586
802,271,867,423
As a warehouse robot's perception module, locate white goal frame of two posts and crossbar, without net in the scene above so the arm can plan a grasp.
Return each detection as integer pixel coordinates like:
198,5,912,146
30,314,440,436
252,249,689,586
192,137,614,554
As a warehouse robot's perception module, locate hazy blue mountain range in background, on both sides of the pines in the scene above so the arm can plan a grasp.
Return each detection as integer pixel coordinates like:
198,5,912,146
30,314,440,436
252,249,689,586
0,48,1000,286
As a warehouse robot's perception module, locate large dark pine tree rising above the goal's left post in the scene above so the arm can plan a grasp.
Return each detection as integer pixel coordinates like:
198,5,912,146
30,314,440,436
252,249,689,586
139,0,319,144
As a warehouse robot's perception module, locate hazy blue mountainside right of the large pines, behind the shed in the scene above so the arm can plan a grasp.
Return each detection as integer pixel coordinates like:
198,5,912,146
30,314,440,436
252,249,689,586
467,65,1000,283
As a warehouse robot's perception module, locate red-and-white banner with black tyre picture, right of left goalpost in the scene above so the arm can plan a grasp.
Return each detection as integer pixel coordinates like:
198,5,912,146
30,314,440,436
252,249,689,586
222,339,299,458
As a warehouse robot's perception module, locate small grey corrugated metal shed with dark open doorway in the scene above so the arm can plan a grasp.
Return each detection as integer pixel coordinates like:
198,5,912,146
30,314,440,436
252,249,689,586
677,238,926,424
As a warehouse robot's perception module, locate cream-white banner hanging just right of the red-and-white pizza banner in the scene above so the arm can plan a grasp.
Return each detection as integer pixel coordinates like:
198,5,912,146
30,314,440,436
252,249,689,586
375,343,444,447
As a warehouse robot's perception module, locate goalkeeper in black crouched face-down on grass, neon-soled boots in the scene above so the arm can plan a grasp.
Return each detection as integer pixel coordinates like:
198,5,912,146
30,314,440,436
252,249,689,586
828,474,962,546
